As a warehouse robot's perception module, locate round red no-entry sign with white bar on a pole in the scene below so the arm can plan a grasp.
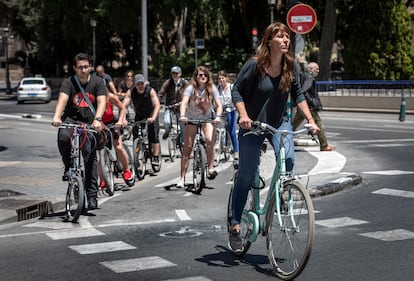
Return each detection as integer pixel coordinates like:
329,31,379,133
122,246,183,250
286,4,316,34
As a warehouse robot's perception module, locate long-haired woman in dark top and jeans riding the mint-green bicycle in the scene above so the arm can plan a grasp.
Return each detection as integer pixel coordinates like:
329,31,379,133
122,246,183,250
229,22,319,249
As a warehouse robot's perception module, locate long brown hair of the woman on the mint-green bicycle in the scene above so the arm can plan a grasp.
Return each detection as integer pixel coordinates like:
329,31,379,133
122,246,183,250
255,22,294,93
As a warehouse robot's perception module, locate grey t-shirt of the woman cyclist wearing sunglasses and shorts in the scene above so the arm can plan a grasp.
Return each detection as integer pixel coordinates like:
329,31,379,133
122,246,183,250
183,85,220,120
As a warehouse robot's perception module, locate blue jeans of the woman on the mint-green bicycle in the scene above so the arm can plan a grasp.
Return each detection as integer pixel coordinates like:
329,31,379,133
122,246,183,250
231,119,295,224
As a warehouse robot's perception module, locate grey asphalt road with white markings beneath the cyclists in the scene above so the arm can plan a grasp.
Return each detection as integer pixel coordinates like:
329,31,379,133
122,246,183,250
0,101,414,281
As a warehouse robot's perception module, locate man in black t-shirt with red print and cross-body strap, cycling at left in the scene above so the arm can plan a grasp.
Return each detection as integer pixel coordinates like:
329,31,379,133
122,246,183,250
52,53,107,210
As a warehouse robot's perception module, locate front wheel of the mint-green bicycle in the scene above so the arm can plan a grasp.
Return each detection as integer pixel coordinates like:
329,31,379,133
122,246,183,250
266,182,315,280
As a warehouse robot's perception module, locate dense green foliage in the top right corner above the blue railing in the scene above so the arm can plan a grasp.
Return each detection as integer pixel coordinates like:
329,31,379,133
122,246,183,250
337,0,414,79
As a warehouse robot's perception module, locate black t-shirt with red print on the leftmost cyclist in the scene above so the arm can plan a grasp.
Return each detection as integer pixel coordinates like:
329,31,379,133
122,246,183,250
59,75,106,123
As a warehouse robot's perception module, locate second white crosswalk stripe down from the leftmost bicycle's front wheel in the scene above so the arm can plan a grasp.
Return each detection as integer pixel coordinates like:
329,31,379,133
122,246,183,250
69,238,136,255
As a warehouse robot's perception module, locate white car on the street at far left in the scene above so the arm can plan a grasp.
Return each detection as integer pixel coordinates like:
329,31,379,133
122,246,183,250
17,77,52,104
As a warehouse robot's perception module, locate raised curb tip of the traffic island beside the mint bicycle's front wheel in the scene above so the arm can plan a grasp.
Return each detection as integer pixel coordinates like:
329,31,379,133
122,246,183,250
309,174,362,197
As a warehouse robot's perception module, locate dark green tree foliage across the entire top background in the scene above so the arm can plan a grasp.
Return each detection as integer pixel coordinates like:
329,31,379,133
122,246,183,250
0,0,414,79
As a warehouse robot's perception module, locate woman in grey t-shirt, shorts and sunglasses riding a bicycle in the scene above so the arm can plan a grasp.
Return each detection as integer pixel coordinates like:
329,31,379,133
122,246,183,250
177,66,222,188
